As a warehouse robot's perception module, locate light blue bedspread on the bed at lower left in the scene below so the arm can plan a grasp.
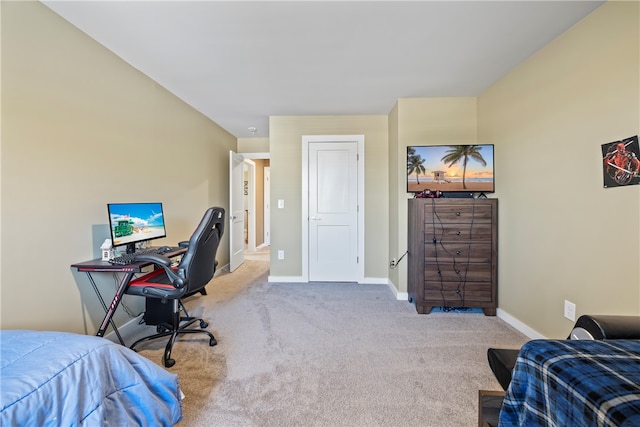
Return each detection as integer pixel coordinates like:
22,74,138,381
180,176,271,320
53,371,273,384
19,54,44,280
0,331,182,427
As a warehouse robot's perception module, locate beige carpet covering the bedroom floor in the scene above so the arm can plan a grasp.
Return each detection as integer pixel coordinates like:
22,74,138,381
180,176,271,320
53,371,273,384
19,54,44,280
132,260,527,427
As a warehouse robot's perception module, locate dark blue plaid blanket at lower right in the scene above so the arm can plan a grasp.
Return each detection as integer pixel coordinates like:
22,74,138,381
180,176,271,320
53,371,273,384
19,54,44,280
499,340,640,427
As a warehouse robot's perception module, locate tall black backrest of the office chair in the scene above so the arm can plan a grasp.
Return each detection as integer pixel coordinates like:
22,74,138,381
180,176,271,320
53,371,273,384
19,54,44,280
178,207,225,293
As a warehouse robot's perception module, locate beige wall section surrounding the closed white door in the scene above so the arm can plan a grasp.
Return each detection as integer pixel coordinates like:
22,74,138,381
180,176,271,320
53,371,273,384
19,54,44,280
269,116,389,280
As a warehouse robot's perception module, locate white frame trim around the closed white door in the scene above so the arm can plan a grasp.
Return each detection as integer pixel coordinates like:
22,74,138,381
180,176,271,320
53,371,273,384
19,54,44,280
300,135,365,283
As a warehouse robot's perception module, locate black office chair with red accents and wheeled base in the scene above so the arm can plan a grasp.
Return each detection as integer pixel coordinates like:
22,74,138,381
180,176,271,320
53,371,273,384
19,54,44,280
126,207,224,368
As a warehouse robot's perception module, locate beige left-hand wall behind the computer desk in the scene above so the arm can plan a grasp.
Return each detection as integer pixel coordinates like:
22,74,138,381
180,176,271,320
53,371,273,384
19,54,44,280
0,2,236,333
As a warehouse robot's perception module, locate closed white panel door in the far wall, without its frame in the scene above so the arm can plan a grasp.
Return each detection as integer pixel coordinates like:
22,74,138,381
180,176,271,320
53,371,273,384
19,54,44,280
308,142,358,282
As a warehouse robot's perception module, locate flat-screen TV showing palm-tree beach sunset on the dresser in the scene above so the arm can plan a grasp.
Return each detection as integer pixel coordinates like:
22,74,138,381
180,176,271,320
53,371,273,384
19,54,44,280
407,145,494,193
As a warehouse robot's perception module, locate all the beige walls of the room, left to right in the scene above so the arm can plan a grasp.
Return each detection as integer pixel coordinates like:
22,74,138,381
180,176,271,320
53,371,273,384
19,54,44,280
0,2,640,337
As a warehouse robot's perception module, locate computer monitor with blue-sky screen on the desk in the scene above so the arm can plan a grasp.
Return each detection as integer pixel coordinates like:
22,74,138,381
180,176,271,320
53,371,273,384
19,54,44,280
107,203,167,254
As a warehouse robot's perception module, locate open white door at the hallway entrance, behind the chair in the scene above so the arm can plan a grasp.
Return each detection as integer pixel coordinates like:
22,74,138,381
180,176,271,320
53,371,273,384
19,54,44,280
229,151,244,271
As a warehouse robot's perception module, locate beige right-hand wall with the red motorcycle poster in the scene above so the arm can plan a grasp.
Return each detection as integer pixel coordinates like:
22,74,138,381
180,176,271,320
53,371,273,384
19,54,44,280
478,2,640,338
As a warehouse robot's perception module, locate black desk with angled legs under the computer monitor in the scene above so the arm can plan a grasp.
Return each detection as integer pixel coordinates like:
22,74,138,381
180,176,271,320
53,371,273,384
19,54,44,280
71,248,187,345
